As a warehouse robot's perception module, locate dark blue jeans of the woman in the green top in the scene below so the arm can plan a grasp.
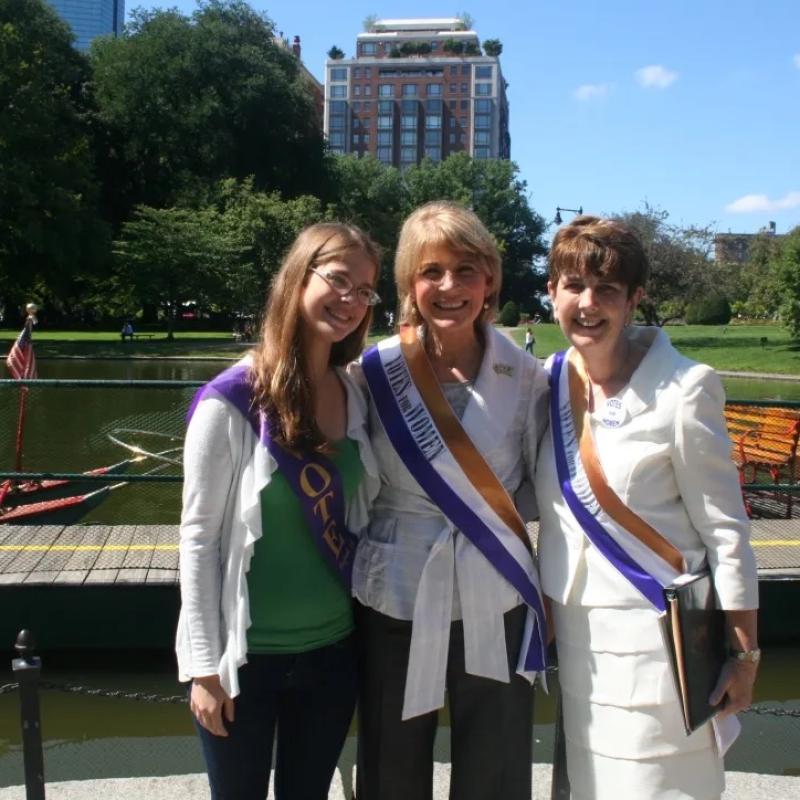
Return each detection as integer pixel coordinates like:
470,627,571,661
195,636,357,800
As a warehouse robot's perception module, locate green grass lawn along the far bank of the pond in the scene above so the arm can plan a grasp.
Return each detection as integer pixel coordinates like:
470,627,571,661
6,323,800,375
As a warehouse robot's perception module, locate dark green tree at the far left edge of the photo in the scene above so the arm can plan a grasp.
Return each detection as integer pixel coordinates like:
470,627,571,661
0,0,109,318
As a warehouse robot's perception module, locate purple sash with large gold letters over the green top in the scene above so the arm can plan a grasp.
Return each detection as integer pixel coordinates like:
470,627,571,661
186,365,358,591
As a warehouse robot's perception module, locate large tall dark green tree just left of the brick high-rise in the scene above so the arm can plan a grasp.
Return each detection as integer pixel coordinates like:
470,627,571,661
91,0,327,221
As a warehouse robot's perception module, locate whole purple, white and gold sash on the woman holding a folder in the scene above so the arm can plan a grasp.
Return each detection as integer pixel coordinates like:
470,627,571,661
550,350,685,612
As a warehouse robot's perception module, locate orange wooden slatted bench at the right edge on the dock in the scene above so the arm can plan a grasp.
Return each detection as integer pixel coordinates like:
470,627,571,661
725,403,800,517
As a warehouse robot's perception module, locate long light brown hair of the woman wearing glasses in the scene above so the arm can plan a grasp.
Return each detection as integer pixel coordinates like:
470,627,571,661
251,222,380,450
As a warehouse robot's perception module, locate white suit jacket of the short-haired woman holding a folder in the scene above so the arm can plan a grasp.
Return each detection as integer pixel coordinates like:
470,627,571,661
536,328,758,609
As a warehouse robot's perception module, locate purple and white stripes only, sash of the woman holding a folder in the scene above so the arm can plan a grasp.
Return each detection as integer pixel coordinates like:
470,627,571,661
550,352,681,612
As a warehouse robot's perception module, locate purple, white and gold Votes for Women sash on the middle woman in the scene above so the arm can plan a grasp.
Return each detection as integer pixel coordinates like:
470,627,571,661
362,326,546,673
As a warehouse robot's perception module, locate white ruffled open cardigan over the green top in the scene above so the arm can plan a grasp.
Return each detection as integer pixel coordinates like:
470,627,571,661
175,359,379,697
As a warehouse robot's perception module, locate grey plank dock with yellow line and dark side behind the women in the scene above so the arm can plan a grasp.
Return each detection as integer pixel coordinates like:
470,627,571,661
0,519,800,651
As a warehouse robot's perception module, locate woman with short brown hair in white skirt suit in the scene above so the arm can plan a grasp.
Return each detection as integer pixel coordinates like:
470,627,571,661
536,216,760,800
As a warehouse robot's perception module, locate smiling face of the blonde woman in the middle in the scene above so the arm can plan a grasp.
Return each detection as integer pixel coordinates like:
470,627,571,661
412,244,492,336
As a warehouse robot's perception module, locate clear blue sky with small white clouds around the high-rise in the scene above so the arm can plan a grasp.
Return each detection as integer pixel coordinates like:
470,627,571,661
127,0,800,238
